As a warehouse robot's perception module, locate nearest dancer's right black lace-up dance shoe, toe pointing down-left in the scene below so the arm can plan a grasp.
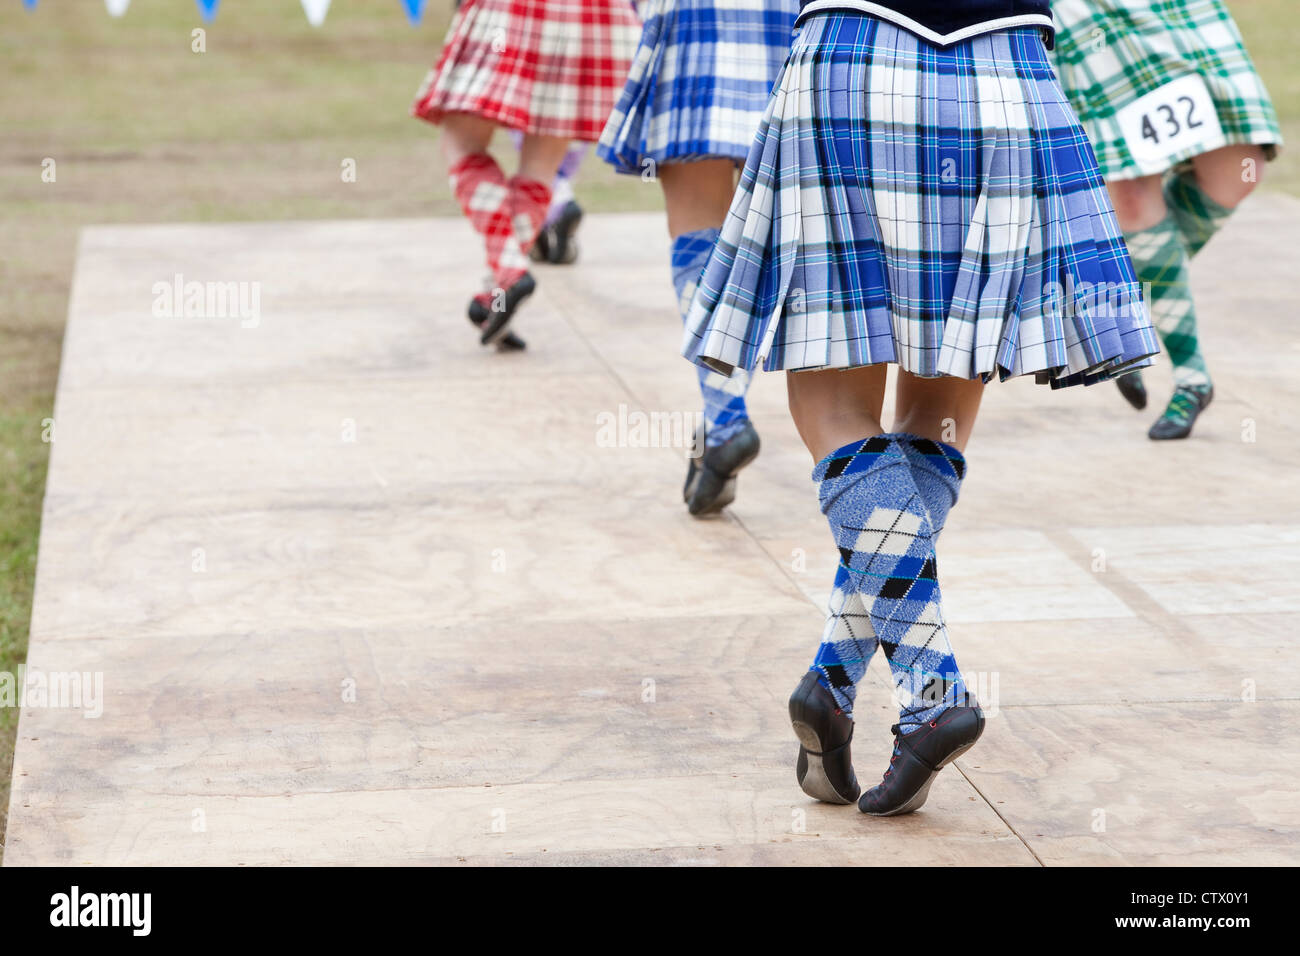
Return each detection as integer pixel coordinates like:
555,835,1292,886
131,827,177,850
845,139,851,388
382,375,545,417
858,697,984,817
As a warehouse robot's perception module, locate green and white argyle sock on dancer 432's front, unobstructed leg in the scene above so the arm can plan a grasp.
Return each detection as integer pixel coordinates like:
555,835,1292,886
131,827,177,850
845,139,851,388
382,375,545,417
1125,213,1210,388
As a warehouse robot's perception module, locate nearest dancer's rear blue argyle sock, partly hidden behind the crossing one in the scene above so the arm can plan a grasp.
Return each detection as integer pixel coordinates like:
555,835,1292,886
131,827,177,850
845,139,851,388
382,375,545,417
813,434,966,713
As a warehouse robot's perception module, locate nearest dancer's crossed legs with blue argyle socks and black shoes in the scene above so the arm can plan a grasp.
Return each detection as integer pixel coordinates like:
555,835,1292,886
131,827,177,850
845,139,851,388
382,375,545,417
787,367,984,816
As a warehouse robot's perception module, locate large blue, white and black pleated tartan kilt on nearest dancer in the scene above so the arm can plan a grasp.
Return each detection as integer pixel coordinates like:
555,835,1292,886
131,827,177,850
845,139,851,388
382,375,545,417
683,13,1158,388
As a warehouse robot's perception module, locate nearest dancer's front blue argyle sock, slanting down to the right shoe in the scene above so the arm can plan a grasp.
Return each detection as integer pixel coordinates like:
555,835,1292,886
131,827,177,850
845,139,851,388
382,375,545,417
813,434,966,734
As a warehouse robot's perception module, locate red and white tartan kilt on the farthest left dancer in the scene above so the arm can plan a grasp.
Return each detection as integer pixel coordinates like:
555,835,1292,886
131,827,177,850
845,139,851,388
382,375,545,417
411,0,641,143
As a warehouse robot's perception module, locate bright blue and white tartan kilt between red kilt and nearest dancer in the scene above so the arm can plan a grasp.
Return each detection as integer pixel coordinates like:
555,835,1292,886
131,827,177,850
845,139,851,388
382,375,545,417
597,0,800,173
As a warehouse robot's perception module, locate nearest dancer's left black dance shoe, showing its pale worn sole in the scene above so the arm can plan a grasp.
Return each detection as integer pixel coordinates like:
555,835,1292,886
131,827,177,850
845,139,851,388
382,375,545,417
790,671,862,804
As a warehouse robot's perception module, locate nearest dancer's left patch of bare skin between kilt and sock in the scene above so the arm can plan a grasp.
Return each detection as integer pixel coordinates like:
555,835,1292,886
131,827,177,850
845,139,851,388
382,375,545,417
785,364,885,462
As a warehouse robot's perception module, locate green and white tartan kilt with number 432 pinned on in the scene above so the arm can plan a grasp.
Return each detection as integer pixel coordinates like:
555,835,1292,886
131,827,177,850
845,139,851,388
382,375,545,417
1052,0,1282,179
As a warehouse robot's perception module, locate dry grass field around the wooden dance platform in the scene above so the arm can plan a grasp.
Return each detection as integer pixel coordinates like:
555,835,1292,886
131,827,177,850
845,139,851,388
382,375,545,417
0,0,1300,851
